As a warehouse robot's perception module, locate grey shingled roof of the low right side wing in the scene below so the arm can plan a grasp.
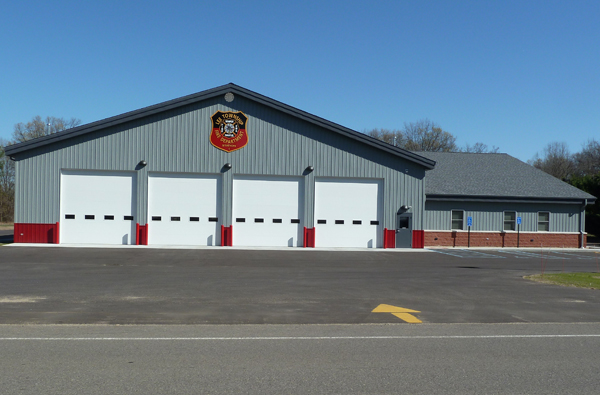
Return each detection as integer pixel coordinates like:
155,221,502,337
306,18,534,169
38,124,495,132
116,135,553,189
419,152,596,203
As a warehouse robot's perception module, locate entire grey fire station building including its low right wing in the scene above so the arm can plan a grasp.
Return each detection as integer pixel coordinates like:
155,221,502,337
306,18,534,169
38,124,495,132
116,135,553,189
5,84,595,248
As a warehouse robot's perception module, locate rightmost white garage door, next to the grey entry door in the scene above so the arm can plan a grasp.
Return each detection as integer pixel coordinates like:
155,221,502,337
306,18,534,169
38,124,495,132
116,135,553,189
315,179,383,248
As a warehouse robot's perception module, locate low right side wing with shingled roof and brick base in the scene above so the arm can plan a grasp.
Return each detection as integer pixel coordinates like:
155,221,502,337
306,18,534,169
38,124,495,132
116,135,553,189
423,153,595,247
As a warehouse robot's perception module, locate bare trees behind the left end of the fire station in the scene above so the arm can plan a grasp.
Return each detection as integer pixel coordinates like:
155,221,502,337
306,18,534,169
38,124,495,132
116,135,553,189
0,115,81,223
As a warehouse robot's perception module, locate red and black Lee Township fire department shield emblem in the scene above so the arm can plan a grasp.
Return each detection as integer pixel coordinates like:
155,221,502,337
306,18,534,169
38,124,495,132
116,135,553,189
210,111,248,152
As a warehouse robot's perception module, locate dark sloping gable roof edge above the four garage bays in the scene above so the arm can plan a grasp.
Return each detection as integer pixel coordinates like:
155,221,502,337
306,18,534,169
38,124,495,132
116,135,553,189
4,83,435,169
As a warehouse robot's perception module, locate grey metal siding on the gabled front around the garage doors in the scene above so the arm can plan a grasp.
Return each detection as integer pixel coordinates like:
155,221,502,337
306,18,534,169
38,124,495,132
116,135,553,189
15,97,425,229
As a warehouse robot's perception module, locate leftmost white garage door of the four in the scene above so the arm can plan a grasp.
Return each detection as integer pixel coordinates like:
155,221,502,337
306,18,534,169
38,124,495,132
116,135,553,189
60,170,136,244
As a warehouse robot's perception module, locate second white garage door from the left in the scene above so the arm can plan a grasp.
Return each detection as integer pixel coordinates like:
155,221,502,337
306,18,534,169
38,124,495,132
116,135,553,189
148,173,221,246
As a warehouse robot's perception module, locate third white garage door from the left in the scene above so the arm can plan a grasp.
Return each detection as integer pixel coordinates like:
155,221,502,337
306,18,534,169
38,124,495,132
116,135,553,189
233,177,304,247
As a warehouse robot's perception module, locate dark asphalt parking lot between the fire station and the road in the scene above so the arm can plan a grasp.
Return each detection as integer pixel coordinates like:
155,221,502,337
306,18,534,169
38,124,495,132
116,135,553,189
0,246,600,324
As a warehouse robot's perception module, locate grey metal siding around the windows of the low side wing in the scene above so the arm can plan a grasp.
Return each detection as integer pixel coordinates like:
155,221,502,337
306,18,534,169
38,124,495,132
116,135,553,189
424,201,581,232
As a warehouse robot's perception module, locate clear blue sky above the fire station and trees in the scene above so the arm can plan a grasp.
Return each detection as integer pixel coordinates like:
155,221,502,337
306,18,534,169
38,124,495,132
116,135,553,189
0,0,600,161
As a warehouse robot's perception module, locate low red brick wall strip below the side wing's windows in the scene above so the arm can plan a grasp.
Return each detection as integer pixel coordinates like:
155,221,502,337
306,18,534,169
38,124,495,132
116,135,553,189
425,230,587,248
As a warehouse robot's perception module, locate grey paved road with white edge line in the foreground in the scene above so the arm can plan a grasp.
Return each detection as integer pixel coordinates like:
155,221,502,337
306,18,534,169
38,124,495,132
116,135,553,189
0,324,600,395
